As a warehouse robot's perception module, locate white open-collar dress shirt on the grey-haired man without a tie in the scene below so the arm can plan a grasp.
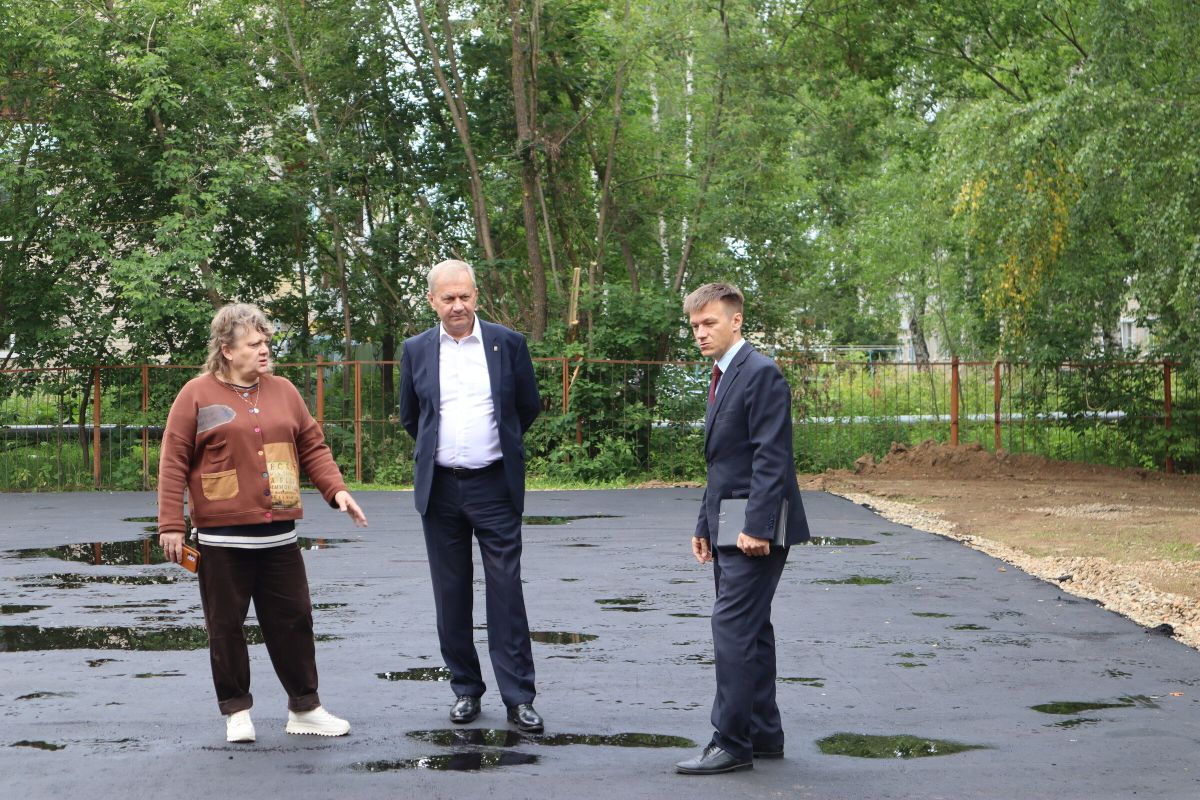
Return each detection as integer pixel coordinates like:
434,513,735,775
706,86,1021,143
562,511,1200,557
434,315,502,469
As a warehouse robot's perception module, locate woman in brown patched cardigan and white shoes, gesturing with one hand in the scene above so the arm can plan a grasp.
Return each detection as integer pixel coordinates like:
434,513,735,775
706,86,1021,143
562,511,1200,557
158,303,367,741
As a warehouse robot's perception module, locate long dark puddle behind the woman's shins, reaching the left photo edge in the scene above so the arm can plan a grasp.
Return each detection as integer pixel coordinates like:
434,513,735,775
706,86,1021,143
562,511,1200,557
0,625,267,652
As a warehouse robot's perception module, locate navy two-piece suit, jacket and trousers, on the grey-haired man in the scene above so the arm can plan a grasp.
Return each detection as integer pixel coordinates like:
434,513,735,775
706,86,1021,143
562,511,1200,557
400,319,541,705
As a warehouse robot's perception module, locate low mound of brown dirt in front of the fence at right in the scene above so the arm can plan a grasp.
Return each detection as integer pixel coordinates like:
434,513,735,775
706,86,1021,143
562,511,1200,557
826,439,1158,480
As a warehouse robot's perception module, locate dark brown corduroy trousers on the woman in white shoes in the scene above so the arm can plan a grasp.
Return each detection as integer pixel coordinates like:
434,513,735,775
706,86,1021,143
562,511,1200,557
199,543,320,715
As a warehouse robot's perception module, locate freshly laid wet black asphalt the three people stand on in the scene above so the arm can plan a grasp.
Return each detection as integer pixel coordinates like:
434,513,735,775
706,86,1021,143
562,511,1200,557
0,489,1200,800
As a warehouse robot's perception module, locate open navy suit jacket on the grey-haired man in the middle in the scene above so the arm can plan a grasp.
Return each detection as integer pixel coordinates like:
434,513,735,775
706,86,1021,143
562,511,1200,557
400,319,541,515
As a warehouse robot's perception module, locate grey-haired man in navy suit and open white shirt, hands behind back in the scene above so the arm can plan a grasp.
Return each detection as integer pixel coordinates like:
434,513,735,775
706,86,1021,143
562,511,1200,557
400,260,544,733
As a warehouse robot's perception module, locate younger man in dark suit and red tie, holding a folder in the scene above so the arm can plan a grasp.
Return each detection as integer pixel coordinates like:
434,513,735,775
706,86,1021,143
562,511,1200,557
676,283,809,775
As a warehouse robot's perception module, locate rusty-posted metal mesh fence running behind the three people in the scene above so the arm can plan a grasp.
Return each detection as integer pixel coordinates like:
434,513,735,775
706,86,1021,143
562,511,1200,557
0,359,1200,491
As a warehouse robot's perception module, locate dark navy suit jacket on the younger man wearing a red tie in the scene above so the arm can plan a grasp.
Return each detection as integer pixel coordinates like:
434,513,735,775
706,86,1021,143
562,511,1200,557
694,342,809,546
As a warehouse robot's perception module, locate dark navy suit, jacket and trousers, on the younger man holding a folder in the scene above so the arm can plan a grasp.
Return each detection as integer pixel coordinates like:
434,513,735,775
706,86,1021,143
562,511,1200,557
695,342,809,759
